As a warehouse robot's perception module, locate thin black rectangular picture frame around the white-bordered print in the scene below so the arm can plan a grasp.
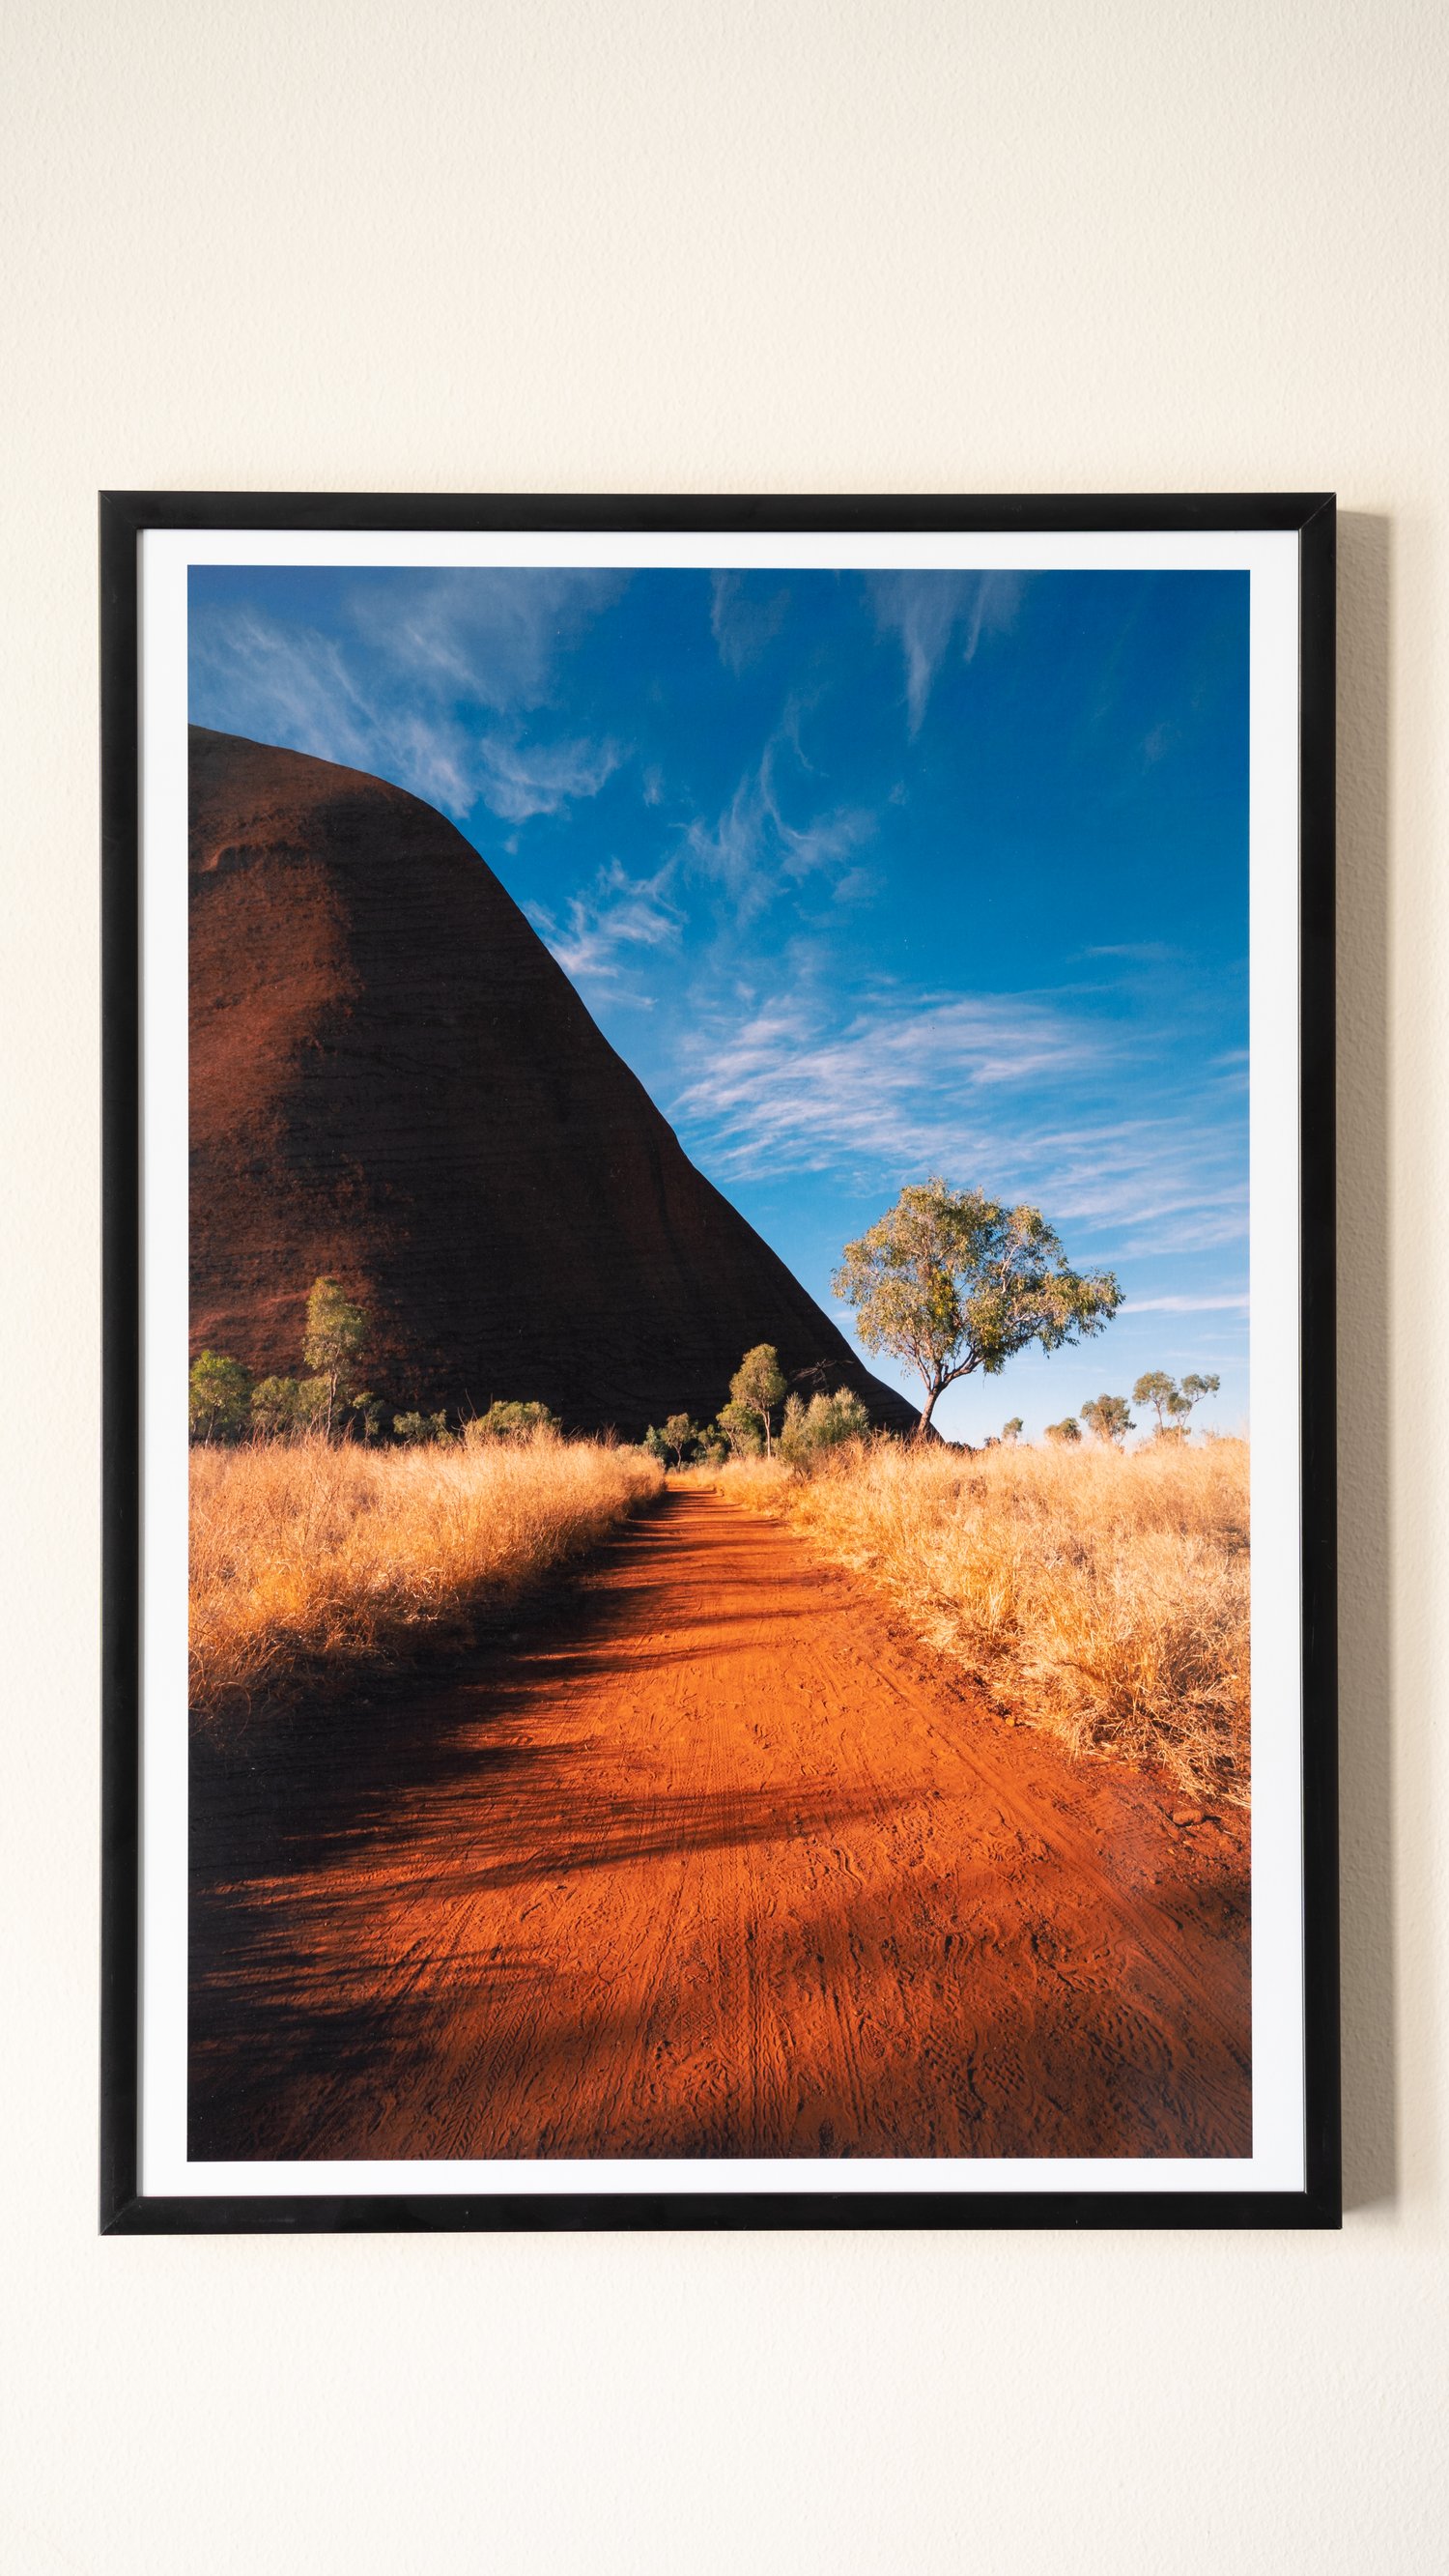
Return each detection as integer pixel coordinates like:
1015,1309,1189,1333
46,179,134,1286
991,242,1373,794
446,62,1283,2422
100,492,1341,2236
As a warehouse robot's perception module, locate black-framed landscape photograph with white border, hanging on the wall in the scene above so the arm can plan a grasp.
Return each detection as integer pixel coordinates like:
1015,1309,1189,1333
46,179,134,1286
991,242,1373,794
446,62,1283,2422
100,492,1338,2233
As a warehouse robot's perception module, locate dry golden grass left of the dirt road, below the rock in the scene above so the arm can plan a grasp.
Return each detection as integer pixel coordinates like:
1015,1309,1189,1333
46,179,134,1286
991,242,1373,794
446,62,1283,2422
190,1440,664,1718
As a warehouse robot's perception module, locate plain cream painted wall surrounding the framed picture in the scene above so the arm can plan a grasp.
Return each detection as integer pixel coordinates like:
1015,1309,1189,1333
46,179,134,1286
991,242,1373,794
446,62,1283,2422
0,0,1449,2576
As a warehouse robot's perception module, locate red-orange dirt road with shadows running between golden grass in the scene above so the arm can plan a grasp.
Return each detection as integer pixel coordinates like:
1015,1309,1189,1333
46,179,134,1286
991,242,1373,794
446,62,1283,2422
190,1489,1251,2159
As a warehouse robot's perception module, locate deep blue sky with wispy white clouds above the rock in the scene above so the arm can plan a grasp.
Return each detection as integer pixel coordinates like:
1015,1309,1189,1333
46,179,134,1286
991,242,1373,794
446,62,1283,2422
190,567,1248,1440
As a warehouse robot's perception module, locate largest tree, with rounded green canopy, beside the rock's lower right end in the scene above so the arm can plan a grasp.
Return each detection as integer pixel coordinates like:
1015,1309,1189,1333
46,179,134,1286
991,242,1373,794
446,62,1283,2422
832,1180,1122,1438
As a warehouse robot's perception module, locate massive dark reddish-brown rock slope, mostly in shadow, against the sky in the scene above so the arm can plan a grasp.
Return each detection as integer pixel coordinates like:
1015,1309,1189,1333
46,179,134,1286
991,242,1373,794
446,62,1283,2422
190,727,914,1438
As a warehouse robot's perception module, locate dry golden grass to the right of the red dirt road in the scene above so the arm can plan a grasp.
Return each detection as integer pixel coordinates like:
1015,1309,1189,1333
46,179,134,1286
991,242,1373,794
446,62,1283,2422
721,1440,1248,1803
